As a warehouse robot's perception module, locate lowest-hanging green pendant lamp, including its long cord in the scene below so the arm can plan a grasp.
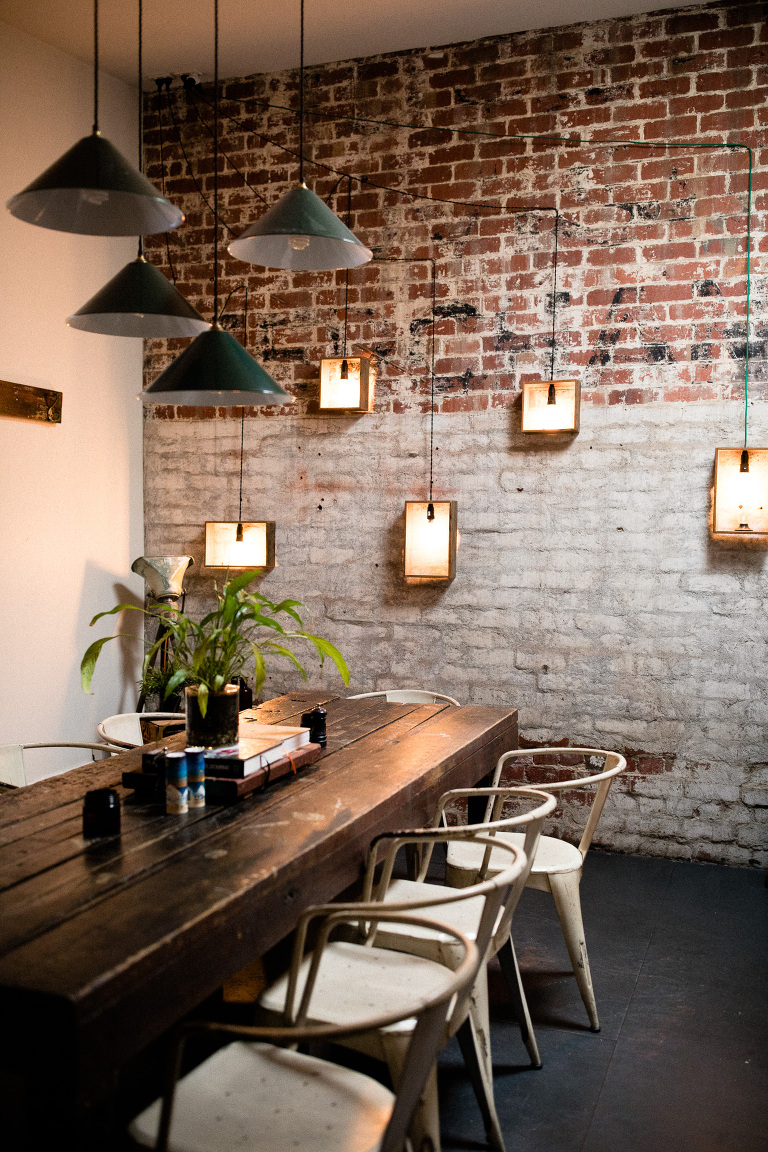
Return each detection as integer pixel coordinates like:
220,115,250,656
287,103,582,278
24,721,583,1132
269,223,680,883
142,0,294,408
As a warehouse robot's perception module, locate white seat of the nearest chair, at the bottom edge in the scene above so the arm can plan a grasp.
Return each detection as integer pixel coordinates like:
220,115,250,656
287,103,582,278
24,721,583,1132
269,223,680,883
129,1041,395,1152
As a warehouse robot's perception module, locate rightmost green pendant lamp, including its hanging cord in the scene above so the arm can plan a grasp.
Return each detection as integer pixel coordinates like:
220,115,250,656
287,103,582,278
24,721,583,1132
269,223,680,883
228,0,373,272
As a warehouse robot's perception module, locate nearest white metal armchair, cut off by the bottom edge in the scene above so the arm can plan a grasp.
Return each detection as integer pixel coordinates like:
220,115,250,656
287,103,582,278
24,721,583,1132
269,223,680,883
129,904,479,1152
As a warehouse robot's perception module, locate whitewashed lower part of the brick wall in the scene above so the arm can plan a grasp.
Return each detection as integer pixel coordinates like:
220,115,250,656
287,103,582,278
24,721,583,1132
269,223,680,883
145,401,768,865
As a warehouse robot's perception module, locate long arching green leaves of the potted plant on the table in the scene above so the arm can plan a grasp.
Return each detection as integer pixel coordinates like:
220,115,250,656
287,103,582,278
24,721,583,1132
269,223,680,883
81,569,349,717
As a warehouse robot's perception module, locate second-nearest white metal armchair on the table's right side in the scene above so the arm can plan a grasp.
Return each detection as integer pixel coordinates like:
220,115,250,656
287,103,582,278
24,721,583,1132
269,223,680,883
259,824,531,1152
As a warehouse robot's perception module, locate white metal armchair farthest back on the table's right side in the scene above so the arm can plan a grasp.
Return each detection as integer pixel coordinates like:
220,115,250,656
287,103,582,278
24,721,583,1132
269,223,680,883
446,748,626,1032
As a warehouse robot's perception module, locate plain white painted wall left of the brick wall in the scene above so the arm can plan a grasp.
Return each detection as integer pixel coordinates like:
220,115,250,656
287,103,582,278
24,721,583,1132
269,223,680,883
0,23,143,779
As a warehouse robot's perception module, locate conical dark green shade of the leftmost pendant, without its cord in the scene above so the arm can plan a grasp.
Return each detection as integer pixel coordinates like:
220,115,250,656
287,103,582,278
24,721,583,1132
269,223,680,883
7,132,184,236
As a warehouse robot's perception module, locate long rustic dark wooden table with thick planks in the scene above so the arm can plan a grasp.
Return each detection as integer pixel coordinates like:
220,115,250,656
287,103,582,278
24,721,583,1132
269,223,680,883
0,692,517,1149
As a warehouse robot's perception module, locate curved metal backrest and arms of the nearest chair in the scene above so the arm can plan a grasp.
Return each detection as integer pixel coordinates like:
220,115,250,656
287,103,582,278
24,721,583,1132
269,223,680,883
157,904,480,1152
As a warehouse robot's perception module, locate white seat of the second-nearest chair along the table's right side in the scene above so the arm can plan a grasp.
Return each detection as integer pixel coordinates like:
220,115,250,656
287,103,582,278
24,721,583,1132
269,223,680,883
259,935,460,1033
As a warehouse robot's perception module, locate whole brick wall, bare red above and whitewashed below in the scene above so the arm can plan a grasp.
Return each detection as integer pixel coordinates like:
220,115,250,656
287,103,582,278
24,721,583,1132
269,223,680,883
141,5,768,863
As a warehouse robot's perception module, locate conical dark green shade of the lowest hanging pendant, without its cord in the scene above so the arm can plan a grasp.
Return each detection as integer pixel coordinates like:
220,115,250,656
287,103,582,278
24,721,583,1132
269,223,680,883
142,324,294,408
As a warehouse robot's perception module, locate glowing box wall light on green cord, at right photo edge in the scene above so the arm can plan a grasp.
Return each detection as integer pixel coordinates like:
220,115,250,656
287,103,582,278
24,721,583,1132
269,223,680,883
712,448,768,541
